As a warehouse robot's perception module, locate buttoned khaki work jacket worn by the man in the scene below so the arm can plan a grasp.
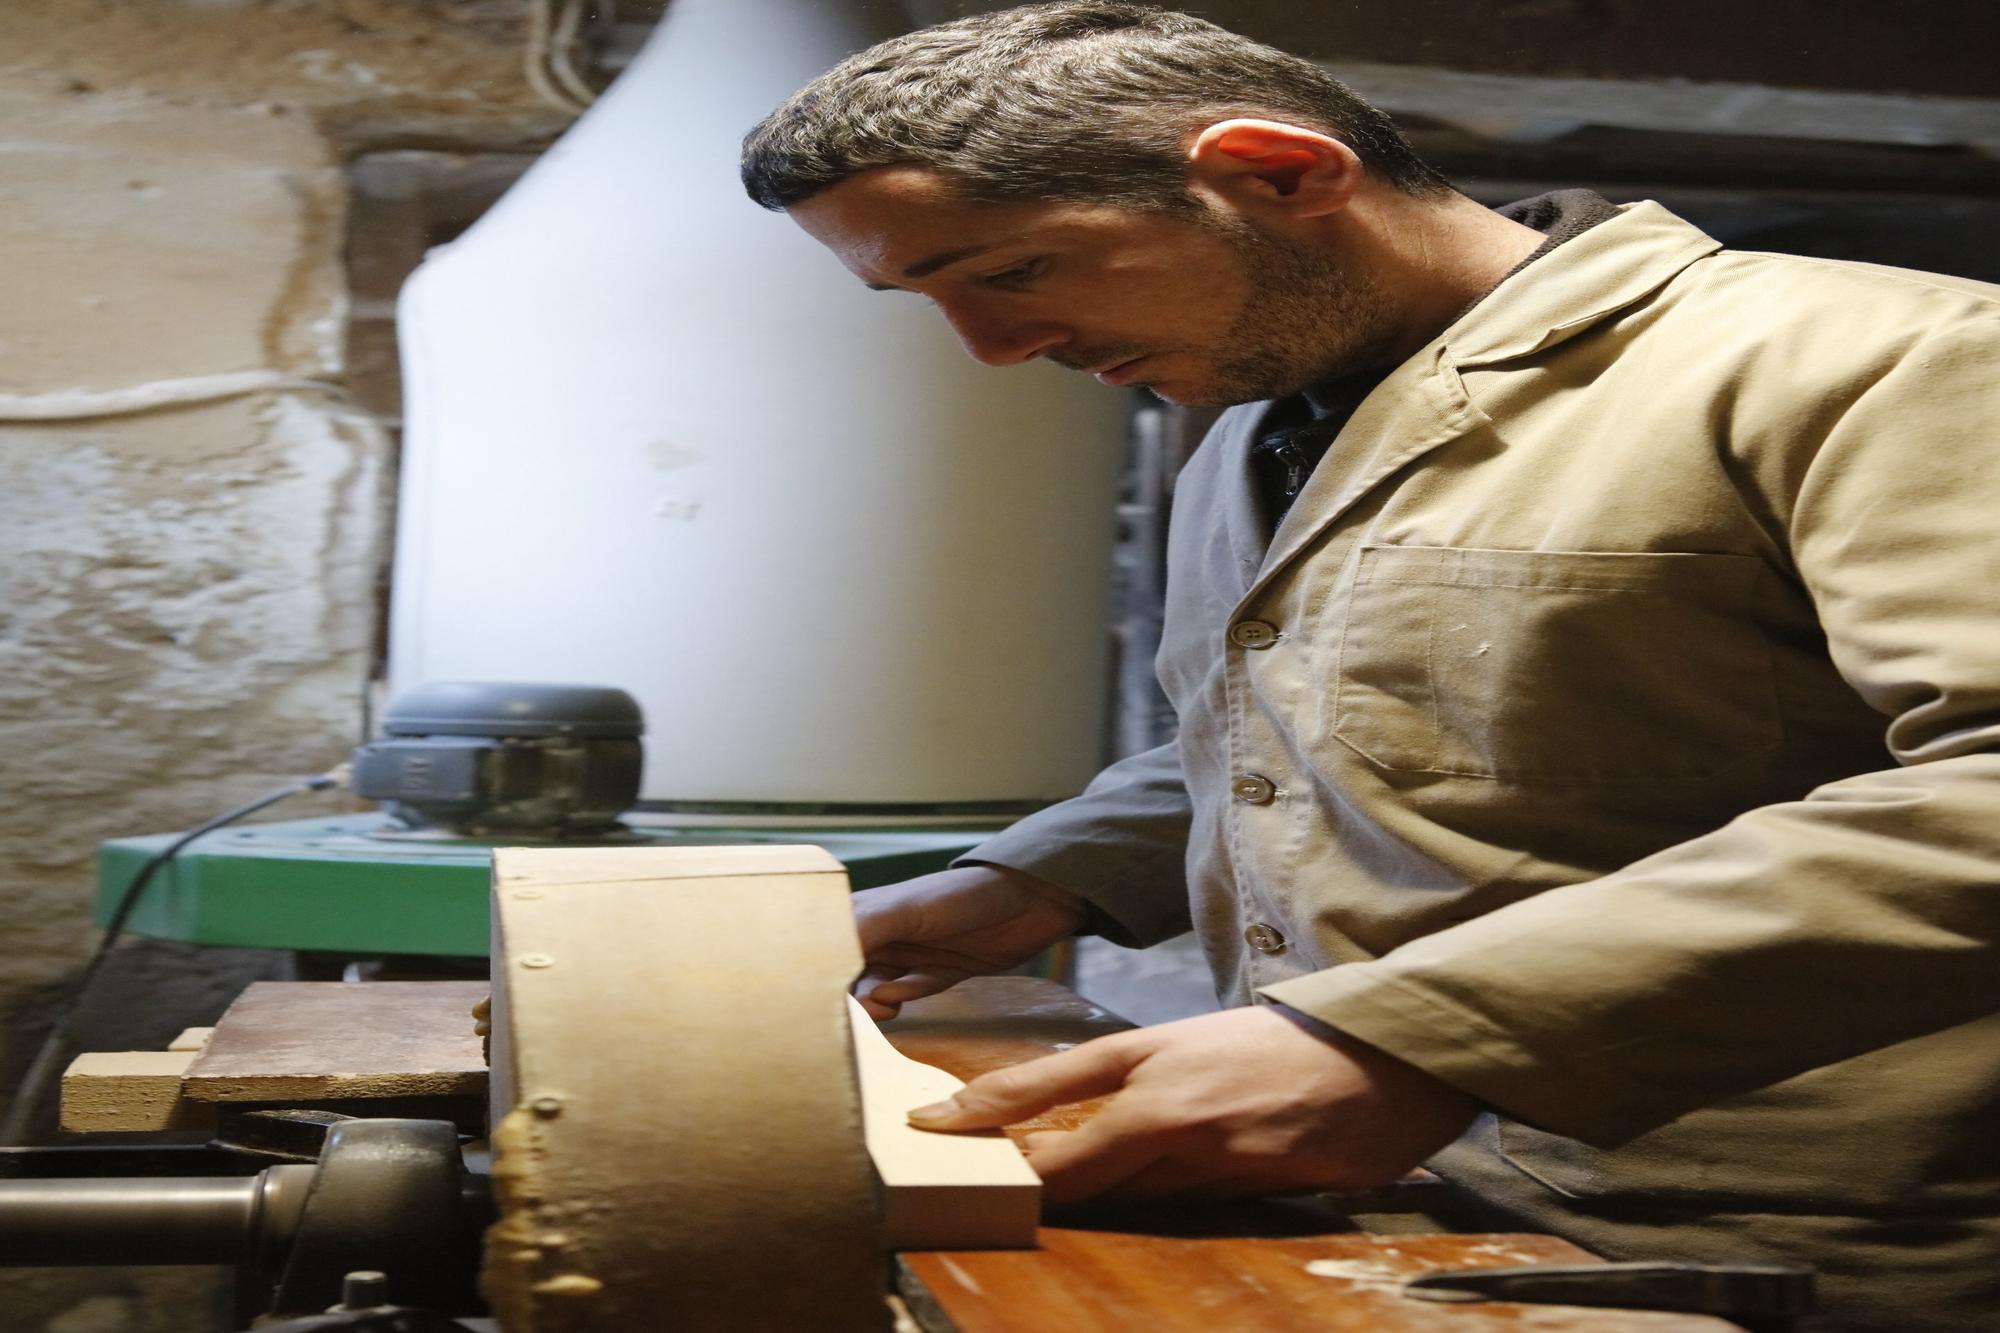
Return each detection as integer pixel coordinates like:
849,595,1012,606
970,204,2000,1329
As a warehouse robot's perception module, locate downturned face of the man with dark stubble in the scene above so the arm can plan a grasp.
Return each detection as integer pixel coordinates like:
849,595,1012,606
790,166,1392,406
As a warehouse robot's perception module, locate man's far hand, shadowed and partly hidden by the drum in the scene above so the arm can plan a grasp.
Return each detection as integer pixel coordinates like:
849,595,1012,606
854,865,1084,1021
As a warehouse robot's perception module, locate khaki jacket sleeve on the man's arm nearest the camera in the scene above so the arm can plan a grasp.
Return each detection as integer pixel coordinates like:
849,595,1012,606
1264,302,2000,1147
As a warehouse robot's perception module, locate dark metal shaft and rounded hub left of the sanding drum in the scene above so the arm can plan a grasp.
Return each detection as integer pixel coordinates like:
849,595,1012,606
0,1119,494,1304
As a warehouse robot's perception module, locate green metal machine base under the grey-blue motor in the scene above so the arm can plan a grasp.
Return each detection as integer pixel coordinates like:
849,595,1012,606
96,815,1004,957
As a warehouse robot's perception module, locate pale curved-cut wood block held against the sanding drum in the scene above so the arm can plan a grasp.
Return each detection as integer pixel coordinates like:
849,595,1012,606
848,997,1042,1249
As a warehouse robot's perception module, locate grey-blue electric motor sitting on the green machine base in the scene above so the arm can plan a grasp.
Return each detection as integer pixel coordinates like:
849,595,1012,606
354,681,646,841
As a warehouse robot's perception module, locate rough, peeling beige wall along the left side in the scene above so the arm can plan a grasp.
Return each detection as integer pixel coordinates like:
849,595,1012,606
0,0,564,1333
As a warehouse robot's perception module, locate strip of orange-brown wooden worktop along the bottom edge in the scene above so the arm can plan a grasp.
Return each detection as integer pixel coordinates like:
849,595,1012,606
900,1205,1736,1333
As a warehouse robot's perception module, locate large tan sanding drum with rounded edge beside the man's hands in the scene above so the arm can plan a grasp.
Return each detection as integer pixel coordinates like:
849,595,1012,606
482,847,890,1333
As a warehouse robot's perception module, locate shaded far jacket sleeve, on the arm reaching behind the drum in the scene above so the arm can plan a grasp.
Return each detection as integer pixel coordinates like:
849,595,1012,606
954,743,1190,949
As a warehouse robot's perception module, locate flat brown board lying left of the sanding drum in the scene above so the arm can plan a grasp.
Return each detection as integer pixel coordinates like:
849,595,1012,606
184,981,486,1103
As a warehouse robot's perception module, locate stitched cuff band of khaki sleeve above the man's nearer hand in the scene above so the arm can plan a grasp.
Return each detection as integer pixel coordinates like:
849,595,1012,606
1258,963,1672,1149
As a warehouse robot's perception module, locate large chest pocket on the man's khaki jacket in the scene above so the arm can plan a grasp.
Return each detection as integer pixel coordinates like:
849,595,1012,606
1332,546,1780,783
